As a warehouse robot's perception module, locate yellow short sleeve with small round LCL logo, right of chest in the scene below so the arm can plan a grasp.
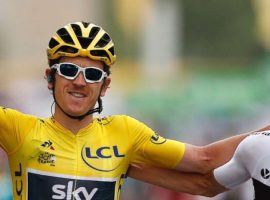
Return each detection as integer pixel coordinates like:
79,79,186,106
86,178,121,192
126,117,185,168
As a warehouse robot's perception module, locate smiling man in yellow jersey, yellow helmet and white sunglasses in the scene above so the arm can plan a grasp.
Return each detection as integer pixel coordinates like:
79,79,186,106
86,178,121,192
0,22,247,200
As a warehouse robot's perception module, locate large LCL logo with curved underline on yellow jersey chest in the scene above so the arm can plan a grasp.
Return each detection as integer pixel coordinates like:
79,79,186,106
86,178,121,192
81,145,125,172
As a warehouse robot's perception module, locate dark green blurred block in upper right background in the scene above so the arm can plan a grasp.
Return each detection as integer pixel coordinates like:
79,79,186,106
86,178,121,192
182,0,261,59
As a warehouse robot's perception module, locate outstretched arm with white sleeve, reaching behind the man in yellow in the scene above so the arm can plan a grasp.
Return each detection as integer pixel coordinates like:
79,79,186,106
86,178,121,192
128,129,262,197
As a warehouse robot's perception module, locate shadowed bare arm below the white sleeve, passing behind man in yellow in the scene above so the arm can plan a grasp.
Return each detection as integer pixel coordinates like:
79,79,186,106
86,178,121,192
128,165,226,197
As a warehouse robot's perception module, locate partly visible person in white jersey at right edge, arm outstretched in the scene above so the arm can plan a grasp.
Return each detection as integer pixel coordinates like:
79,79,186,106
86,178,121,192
129,126,270,200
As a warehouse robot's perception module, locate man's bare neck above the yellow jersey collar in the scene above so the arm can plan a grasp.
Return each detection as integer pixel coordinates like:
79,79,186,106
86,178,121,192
54,106,93,134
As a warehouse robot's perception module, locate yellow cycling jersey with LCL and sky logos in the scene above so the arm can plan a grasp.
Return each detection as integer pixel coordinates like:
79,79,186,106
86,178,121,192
0,107,185,200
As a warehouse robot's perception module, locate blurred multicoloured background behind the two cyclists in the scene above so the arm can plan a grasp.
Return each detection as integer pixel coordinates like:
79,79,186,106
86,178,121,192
0,0,270,200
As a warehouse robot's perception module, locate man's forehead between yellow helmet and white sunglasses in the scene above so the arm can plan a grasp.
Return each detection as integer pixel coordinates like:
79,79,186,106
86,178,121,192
60,56,103,69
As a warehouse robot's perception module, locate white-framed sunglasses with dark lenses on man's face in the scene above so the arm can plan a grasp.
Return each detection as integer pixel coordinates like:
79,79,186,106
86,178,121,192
51,63,108,83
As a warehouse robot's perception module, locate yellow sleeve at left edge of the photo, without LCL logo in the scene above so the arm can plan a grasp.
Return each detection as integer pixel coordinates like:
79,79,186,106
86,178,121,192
0,107,36,154
